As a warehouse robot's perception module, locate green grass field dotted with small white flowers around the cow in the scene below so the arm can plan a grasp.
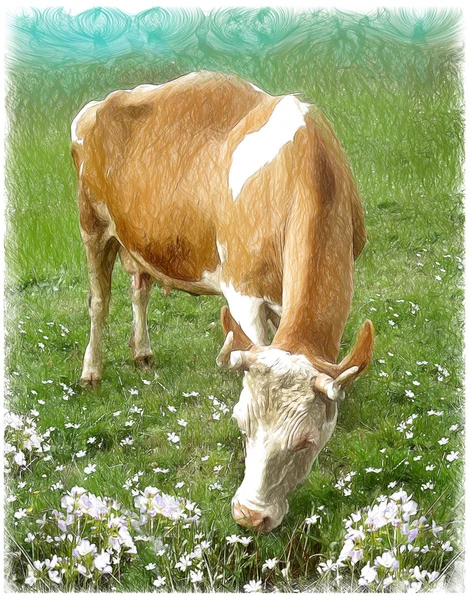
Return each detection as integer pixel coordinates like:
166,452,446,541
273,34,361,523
6,7,464,591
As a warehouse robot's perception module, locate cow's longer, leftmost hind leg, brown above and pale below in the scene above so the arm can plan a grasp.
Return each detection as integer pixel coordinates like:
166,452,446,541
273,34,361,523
80,232,119,384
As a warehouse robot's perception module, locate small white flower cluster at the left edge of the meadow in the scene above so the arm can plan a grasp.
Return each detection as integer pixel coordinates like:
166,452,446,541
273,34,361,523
4,411,55,473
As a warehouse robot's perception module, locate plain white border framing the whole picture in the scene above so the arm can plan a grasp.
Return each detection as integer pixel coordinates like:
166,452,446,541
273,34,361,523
0,0,472,600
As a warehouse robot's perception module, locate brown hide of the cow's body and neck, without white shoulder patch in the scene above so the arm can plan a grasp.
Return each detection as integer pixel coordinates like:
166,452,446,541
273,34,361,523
73,72,365,363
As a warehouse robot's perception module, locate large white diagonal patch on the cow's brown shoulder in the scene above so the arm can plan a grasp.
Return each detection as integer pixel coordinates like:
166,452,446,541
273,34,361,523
228,96,309,200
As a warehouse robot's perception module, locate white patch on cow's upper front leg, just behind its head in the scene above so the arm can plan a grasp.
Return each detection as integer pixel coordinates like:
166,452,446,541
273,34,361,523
221,281,269,346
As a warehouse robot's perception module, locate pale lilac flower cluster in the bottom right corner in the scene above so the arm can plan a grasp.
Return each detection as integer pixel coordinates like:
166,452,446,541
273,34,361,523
318,489,453,592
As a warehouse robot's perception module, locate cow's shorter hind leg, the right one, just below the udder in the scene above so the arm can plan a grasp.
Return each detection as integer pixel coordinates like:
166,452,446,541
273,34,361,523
130,270,153,362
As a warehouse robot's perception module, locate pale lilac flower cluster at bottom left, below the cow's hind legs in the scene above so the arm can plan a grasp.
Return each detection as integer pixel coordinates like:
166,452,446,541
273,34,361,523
25,486,200,589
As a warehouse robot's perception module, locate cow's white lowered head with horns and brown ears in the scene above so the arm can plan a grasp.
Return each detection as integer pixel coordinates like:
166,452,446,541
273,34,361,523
217,307,374,531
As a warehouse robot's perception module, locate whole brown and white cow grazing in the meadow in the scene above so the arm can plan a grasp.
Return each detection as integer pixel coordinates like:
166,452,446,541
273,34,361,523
72,72,374,531
